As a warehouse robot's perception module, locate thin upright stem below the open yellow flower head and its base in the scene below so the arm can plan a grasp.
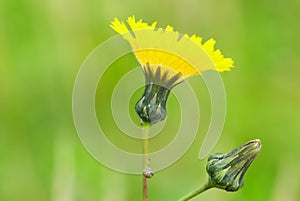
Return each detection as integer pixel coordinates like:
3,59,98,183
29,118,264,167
143,124,149,201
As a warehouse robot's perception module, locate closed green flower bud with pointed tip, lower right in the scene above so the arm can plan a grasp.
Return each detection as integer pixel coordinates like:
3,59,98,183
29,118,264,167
206,140,261,191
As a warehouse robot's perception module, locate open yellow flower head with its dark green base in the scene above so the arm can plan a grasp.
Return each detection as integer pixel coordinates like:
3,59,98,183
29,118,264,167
110,16,233,124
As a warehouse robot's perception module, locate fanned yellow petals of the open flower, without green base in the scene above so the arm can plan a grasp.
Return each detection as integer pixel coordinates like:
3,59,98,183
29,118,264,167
110,16,233,78
